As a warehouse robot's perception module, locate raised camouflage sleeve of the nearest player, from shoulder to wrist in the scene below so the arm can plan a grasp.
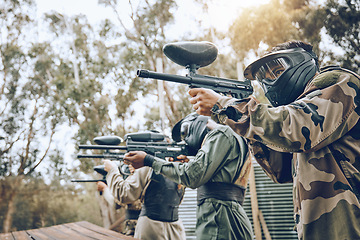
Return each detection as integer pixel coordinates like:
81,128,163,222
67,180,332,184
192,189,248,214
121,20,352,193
213,71,360,152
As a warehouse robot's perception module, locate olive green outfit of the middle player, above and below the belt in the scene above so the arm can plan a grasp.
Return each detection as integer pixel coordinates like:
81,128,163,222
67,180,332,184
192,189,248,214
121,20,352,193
152,125,253,240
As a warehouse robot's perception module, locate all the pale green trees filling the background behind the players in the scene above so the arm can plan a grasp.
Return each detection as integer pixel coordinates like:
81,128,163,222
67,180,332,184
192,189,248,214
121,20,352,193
0,0,359,233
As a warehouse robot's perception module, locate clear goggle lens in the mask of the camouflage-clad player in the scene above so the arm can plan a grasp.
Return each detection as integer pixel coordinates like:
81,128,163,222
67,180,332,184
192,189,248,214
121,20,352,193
253,57,291,82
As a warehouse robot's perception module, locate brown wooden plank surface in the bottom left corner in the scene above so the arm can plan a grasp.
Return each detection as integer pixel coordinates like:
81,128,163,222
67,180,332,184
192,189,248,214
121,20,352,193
0,221,136,240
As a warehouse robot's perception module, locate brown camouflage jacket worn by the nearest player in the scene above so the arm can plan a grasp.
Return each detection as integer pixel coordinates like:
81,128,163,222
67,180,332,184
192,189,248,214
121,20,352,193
212,70,360,240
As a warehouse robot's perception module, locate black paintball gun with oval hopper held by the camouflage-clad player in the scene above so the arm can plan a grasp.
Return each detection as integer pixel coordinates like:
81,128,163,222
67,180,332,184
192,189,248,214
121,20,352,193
136,42,253,99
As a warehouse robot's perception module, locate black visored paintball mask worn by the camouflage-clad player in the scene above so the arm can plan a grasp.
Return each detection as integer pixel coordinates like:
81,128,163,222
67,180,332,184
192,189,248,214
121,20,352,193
244,48,319,107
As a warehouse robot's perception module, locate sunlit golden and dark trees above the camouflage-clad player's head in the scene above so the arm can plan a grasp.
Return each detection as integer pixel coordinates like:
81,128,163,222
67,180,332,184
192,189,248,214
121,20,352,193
229,0,360,72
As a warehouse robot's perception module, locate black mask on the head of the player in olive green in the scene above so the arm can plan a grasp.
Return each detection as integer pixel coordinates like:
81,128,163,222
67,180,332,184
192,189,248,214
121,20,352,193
172,113,210,156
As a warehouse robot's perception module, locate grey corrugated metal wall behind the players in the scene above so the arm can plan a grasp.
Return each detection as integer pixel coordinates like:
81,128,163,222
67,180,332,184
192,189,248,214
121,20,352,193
179,162,297,240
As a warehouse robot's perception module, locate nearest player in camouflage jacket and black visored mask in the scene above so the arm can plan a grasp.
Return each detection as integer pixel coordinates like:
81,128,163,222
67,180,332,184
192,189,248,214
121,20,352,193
189,41,360,240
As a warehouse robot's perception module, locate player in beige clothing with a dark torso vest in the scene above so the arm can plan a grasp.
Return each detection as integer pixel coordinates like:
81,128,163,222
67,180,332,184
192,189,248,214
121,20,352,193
104,156,186,240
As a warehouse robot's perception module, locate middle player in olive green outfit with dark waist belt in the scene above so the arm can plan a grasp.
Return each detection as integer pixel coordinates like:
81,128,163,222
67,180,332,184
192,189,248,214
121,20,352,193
124,113,253,240
